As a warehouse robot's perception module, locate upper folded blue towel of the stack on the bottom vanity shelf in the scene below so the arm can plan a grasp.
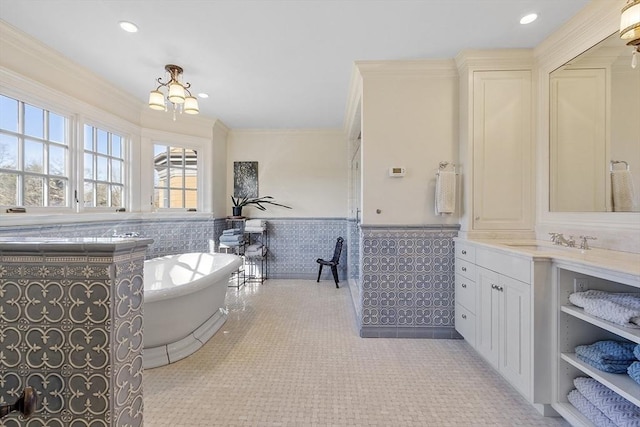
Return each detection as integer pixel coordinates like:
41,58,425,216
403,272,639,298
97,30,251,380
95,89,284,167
573,377,640,427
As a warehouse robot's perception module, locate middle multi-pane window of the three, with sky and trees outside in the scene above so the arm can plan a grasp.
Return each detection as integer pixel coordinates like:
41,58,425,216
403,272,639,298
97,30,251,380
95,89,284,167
84,125,125,208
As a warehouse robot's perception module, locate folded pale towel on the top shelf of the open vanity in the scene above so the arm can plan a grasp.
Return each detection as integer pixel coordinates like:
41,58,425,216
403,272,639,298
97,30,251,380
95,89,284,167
569,289,640,328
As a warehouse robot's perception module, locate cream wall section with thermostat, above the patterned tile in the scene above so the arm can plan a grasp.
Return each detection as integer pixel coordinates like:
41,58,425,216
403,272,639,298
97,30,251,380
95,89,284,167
357,61,459,225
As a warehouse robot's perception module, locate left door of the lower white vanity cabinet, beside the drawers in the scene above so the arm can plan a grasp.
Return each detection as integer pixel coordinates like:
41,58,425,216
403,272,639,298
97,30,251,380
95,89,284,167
476,267,501,368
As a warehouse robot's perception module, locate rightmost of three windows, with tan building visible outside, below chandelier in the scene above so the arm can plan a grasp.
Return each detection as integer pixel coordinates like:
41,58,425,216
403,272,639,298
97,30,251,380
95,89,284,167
153,144,198,209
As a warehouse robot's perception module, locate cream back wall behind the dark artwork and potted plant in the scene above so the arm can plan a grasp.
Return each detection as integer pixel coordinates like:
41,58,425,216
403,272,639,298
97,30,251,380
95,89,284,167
226,130,349,218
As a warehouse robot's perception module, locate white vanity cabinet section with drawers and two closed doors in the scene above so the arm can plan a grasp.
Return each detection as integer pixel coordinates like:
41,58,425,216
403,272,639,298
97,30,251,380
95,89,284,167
455,238,552,414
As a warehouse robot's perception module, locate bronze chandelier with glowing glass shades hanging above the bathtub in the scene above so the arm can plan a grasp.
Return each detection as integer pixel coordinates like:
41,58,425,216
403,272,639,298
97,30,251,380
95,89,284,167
149,64,200,121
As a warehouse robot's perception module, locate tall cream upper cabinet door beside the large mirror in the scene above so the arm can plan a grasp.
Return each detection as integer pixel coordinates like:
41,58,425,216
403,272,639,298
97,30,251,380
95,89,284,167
472,70,533,230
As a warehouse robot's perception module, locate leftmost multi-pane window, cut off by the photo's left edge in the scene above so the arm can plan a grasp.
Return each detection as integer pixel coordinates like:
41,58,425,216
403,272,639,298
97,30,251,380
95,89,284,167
0,95,70,207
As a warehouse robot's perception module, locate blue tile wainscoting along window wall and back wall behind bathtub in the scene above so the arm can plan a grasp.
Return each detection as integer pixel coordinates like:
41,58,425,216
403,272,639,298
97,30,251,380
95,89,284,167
0,219,348,282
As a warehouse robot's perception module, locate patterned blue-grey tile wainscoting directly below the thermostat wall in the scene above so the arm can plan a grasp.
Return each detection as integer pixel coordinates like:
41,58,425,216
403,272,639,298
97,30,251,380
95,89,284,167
354,225,460,338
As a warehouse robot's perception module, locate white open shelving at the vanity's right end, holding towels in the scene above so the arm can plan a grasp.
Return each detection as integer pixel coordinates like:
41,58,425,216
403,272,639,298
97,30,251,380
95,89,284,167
552,261,640,426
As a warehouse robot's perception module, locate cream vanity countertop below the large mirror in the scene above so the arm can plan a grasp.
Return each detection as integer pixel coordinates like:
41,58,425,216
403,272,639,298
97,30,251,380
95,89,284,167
454,238,640,287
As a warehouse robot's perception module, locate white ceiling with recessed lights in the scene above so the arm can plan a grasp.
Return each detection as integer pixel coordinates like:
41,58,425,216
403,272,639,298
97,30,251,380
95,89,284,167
0,0,589,129
